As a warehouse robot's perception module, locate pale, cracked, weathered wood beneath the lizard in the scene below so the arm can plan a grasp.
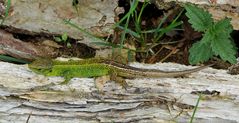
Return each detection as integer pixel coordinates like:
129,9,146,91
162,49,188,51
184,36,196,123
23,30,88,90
0,62,239,123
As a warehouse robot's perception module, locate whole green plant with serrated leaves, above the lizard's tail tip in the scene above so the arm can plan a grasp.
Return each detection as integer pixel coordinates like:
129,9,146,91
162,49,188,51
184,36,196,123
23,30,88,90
185,4,237,64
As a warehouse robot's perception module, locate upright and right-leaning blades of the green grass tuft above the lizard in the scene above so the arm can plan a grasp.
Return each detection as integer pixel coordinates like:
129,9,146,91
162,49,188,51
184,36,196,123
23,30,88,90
115,0,182,54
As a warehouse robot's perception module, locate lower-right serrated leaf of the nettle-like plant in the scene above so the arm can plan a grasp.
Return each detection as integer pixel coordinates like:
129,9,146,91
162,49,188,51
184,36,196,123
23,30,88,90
211,35,237,64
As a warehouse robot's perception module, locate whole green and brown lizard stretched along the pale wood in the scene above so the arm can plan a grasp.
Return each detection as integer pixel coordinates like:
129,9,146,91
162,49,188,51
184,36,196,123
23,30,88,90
28,58,211,86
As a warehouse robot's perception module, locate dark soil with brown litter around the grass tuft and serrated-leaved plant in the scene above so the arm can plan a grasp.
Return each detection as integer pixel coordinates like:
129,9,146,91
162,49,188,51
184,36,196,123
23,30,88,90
119,1,239,68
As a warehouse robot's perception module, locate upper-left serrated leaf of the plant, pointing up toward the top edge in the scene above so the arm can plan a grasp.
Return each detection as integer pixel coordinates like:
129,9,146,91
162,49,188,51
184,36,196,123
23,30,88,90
185,4,213,32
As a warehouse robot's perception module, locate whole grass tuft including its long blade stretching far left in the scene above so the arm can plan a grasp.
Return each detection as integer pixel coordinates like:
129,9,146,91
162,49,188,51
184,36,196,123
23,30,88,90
64,0,182,59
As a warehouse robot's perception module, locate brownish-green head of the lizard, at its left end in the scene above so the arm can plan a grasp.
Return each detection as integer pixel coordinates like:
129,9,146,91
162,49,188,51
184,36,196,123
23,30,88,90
28,59,53,74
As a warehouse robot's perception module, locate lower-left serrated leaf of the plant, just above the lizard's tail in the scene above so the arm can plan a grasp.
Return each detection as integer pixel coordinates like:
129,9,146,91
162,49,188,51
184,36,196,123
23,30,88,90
189,41,213,64
